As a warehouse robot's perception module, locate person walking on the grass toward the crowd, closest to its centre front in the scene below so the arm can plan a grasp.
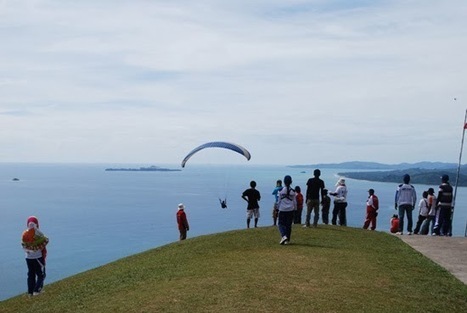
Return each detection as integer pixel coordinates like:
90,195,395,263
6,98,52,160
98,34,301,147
278,175,297,245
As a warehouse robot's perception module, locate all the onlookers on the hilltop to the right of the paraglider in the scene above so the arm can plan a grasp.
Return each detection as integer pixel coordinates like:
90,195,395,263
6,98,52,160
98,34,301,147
236,169,453,244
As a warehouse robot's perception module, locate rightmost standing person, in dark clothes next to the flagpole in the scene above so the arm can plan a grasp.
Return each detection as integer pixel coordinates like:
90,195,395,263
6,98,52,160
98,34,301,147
433,175,453,236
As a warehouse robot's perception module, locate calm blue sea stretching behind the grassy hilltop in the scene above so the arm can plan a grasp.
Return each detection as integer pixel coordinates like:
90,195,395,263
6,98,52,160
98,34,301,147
0,162,467,301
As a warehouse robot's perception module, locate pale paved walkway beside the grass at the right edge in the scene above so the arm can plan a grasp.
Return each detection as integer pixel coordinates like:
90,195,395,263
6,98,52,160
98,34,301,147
399,235,467,284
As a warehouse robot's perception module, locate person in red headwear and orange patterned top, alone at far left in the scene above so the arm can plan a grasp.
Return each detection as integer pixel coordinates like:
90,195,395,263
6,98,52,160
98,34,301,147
21,216,49,296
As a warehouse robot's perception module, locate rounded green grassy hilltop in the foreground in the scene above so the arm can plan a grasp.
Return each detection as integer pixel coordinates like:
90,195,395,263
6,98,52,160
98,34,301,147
0,226,467,313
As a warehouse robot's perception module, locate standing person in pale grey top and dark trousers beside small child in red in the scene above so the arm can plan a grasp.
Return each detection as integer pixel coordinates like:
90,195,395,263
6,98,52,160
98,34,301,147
394,174,417,235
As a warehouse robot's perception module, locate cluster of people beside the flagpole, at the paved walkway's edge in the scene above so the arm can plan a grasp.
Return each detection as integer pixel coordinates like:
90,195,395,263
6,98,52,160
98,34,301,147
390,174,453,236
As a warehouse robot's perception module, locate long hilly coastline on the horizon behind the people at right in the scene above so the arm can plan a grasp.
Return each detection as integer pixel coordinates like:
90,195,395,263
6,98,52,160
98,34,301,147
290,161,467,186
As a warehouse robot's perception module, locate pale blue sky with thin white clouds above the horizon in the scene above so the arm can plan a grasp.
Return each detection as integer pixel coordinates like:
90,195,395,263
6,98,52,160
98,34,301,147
0,0,467,165
